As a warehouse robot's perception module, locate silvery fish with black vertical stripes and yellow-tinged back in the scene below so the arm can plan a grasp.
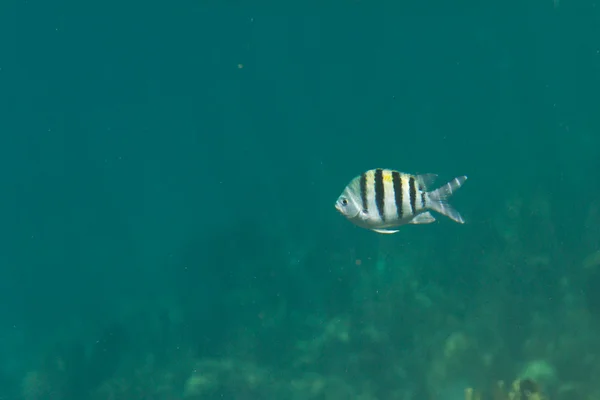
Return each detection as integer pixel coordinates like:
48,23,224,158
335,168,467,233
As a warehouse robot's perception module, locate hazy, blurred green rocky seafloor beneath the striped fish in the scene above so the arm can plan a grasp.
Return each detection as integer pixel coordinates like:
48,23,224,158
9,196,600,400
